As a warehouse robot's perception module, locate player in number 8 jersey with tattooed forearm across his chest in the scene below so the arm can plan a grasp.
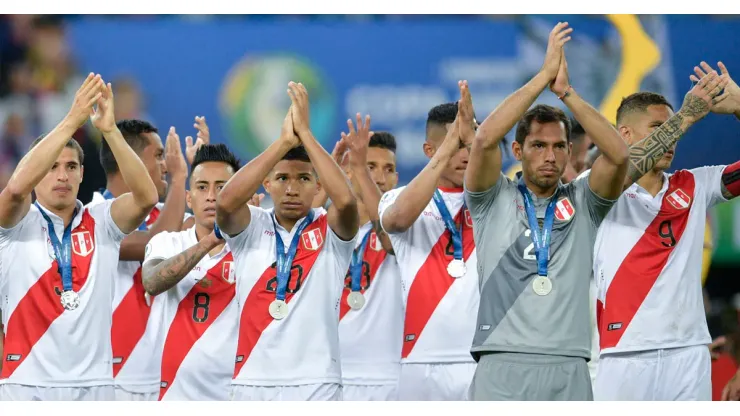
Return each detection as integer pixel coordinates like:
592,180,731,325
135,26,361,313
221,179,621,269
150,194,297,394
142,144,239,400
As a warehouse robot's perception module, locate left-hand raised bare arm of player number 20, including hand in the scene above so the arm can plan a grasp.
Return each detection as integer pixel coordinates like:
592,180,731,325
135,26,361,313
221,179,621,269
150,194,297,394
216,106,301,236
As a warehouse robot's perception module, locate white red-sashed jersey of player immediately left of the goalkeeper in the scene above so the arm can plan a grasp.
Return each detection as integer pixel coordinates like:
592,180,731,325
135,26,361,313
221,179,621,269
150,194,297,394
378,187,480,364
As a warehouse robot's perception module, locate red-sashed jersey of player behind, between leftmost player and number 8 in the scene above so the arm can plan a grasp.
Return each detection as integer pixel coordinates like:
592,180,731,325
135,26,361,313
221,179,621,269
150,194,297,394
90,191,190,393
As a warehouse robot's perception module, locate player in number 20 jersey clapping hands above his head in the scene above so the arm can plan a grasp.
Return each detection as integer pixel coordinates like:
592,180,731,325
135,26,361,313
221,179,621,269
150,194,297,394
216,82,359,400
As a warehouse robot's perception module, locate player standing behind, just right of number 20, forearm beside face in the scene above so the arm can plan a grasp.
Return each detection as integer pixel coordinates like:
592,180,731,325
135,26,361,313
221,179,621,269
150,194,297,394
330,118,403,401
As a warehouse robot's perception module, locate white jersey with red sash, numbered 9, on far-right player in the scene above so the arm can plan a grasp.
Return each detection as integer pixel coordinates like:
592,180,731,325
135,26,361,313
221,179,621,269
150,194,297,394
594,166,725,354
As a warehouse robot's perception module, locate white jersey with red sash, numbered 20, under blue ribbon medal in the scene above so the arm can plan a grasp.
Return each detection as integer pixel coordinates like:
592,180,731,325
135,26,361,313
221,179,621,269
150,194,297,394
225,206,355,386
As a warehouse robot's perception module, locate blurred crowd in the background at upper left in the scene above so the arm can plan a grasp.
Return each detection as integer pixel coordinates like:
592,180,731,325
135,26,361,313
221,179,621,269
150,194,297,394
0,15,147,202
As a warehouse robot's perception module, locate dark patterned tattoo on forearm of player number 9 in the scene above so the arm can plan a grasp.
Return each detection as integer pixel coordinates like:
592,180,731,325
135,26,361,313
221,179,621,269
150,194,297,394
627,113,684,182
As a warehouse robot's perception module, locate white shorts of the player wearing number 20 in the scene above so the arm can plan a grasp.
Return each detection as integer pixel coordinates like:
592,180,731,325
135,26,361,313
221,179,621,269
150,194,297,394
231,383,342,401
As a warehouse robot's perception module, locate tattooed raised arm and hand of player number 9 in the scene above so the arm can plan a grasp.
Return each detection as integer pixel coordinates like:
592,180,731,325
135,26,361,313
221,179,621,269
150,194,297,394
624,72,727,189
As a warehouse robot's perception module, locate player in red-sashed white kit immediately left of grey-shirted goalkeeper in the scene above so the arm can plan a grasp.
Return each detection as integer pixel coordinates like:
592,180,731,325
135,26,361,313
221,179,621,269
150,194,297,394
376,83,479,400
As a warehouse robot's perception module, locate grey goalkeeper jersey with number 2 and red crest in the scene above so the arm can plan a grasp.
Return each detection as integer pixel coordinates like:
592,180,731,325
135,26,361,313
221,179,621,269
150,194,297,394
465,174,616,361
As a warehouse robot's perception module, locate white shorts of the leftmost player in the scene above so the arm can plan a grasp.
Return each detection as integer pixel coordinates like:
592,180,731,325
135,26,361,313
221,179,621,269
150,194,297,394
0,384,115,402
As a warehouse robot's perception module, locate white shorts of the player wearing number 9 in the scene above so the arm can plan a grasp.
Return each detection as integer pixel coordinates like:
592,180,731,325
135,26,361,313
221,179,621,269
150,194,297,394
594,345,712,401
